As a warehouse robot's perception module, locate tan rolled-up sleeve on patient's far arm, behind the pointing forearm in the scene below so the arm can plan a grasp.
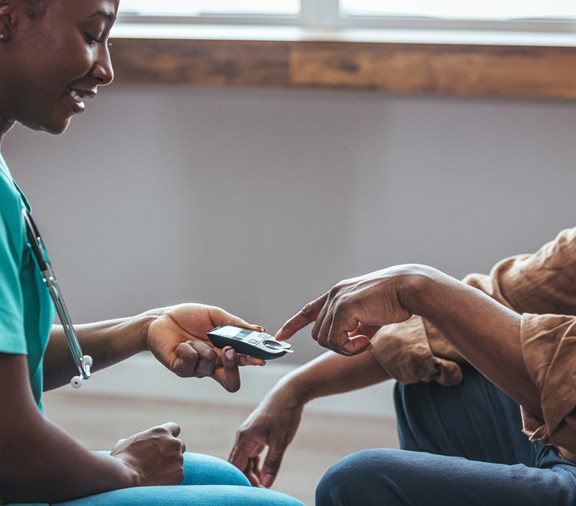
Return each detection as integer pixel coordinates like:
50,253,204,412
372,228,576,385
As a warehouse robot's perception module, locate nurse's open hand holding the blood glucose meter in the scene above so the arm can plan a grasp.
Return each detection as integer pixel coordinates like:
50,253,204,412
147,304,265,392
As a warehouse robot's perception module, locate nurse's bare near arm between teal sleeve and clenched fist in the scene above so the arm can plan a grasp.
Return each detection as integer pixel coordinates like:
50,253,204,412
0,354,138,502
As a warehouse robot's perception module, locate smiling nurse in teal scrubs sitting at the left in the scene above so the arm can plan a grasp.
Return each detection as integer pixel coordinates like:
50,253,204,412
0,0,300,506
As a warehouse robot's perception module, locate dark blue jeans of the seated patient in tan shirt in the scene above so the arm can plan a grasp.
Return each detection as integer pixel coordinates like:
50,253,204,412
316,368,576,506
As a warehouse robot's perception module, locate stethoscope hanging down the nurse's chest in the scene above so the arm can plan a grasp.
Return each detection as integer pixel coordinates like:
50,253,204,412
22,208,92,388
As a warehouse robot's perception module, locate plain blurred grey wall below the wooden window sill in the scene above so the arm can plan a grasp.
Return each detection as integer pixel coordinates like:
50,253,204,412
3,86,576,362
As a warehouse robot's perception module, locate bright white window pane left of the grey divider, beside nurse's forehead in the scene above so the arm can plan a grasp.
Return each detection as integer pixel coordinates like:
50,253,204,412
120,0,300,16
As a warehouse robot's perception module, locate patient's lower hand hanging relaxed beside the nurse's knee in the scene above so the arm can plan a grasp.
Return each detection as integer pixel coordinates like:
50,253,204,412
229,389,304,488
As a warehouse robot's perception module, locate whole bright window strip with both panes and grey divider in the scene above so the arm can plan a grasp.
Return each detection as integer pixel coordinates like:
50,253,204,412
120,0,576,32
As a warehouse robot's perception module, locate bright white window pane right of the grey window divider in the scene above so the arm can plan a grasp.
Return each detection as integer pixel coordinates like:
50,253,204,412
340,0,576,21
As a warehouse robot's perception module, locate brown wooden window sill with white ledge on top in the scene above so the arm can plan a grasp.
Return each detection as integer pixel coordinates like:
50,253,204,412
112,25,576,99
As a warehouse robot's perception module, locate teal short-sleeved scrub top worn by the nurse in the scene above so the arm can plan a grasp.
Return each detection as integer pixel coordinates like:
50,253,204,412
0,155,56,410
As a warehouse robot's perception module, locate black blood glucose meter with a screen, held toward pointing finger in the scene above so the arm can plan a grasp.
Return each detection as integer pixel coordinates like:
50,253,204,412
207,325,294,360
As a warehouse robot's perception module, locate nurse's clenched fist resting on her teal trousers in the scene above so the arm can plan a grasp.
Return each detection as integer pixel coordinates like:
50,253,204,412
111,422,186,487
